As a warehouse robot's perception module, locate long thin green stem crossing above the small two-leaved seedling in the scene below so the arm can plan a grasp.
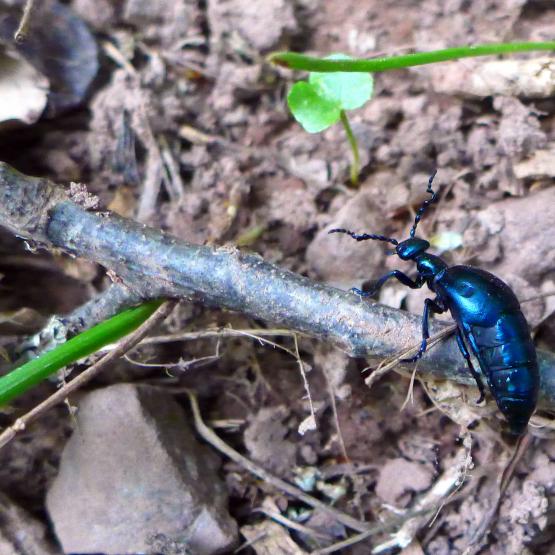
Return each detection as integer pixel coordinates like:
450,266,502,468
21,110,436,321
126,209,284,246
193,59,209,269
268,41,555,73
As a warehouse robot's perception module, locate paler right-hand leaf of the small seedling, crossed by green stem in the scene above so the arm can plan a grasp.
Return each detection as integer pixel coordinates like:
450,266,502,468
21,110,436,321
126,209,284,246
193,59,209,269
308,54,374,110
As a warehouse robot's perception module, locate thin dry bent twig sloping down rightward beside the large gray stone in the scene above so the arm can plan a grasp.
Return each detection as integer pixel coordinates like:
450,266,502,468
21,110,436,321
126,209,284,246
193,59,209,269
186,390,369,532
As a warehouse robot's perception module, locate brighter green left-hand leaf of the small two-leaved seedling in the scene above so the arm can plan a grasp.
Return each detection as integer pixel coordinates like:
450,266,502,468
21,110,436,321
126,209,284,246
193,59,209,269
287,81,341,133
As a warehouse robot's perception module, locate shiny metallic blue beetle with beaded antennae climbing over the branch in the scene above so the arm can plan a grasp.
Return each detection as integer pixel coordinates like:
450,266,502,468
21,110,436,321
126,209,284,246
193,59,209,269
329,172,540,435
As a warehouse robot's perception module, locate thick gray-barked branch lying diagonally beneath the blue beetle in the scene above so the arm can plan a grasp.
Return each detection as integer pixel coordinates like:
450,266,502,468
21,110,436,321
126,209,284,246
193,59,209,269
0,164,555,409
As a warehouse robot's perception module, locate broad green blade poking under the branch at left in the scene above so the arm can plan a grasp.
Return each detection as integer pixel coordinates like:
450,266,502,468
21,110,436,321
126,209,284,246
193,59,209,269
0,300,163,405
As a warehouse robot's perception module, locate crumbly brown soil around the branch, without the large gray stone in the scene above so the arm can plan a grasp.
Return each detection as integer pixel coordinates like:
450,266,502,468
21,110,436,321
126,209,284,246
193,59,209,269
0,0,555,555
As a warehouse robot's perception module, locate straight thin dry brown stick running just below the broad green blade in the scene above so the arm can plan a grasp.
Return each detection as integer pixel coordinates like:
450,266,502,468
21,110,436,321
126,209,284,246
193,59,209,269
0,301,177,449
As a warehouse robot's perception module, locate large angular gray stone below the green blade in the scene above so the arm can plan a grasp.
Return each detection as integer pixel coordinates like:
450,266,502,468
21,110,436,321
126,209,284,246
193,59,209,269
47,384,237,555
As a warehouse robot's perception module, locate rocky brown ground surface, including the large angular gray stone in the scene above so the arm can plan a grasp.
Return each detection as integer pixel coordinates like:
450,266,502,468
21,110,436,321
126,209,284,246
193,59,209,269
0,0,555,555
